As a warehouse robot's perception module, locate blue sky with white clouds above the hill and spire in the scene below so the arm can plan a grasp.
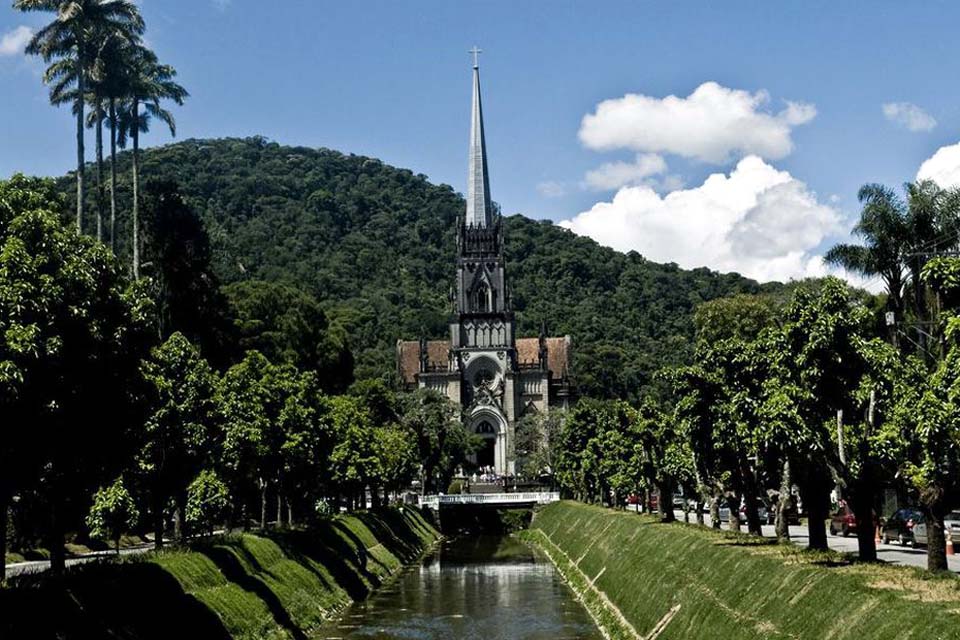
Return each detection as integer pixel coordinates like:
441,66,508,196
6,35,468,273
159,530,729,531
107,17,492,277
0,0,960,279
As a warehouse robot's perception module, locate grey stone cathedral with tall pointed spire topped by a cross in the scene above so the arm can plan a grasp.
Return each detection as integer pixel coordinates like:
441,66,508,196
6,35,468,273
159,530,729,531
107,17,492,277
397,50,571,475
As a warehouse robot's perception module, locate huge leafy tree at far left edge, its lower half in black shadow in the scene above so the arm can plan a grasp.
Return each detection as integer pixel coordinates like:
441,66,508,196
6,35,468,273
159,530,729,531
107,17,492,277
0,176,150,572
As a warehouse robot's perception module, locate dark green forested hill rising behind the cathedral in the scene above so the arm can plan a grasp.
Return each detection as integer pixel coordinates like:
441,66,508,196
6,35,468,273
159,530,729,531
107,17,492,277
65,138,780,396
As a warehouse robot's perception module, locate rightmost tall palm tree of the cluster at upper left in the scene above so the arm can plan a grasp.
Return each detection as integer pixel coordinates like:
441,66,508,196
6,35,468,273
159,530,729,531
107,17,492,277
119,46,190,278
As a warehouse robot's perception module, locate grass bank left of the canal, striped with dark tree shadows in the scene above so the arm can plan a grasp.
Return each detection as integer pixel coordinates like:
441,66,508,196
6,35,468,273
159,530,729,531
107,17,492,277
0,508,438,640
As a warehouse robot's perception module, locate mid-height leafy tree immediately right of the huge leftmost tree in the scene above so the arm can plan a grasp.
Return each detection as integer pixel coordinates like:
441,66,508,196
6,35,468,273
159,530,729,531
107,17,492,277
138,333,222,547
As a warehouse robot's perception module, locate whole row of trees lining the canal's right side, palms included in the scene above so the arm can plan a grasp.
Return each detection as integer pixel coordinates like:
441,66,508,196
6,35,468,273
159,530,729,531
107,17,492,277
554,183,960,570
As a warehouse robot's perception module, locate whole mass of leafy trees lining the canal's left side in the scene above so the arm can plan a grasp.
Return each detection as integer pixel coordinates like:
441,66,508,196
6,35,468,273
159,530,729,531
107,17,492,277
0,176,474,571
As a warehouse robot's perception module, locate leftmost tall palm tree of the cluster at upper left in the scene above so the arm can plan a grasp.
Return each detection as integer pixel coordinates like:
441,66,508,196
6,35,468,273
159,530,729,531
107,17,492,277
13,0,144,231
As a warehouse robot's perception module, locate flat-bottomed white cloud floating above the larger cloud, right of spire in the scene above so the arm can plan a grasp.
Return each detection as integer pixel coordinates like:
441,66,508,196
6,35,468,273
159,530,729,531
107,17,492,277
579,82,817,164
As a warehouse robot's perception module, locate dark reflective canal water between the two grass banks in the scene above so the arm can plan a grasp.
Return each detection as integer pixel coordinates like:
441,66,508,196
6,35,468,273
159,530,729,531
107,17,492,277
313,536,602,640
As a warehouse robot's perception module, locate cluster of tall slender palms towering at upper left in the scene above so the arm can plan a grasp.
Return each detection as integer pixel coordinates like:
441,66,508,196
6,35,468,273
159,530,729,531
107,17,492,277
13,0,189,278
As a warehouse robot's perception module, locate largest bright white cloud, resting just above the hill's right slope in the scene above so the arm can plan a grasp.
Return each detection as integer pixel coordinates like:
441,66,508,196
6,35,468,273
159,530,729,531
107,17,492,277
559,156,847,281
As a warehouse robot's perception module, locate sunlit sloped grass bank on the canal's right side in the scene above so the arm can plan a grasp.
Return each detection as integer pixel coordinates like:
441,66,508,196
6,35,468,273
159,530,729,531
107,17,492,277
524,502,960,640
